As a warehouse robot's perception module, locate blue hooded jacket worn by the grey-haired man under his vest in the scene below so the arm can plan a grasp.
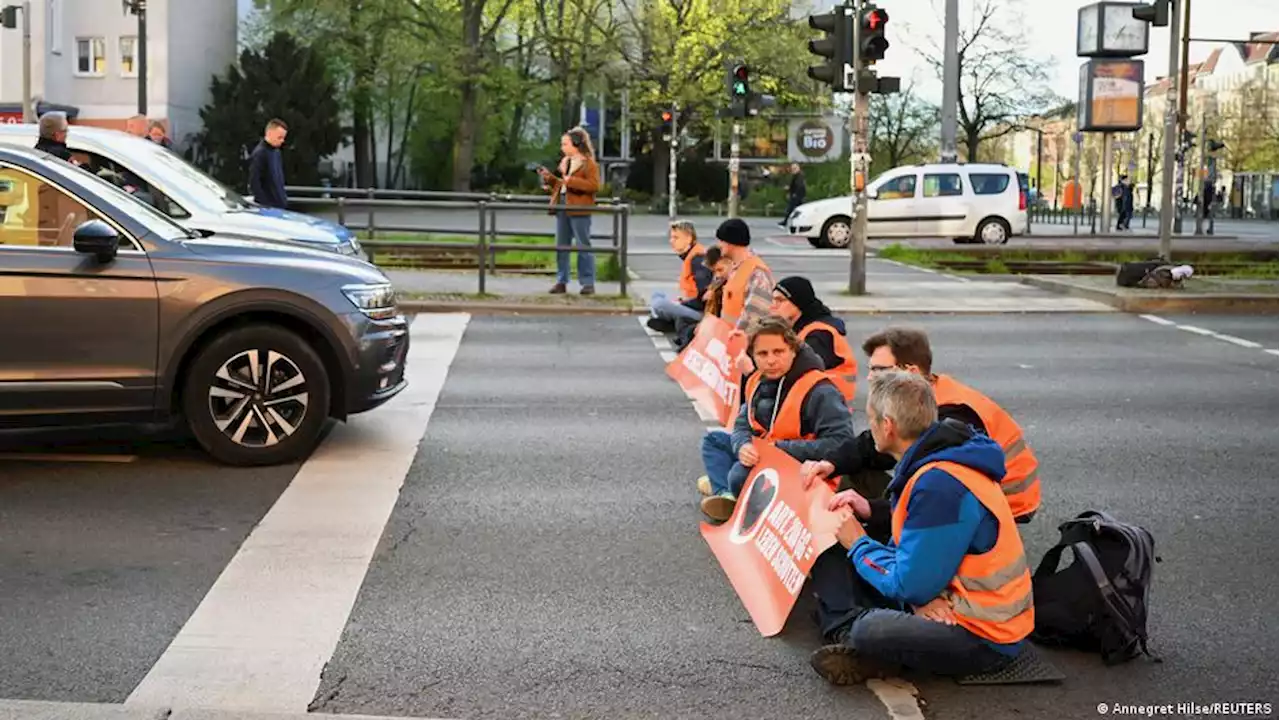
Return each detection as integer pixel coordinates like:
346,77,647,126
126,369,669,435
849,420,1020,652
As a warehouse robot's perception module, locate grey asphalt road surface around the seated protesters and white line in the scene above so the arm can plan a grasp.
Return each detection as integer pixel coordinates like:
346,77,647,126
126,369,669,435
0,314,1280,720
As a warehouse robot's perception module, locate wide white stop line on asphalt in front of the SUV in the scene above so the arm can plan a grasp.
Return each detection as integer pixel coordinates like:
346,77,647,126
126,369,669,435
125,314,470,712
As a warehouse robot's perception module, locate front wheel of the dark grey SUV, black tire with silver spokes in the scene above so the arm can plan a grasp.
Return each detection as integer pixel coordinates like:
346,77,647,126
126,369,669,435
182,324,330,466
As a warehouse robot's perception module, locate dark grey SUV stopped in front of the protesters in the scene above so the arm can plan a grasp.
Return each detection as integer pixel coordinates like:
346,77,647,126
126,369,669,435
0,147,408,465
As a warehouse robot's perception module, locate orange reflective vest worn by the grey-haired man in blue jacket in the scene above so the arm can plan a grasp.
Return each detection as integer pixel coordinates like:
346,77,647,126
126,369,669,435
892,462,1036,644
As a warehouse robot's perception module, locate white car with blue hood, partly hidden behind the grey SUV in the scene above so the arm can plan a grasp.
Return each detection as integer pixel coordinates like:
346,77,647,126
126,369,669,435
0,124,364,258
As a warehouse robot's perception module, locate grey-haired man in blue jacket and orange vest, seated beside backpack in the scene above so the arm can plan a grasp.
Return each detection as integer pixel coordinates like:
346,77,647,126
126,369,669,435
809,372,1036,685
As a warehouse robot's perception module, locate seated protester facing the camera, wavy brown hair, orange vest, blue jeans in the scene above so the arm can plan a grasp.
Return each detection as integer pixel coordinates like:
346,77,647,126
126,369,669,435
698,315,854,521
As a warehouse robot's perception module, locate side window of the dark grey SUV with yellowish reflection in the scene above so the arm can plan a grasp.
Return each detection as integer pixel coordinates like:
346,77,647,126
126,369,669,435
0,167,115,247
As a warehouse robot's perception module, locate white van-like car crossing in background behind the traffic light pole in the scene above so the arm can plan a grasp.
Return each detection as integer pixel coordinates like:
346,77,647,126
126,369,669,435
786,163,1028,247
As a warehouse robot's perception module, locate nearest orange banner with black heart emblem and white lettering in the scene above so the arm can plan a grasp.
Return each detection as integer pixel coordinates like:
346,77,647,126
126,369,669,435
701,441,842,637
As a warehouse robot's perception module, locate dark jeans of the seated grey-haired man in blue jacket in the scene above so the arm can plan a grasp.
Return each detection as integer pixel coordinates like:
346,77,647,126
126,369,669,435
809,544,1015,676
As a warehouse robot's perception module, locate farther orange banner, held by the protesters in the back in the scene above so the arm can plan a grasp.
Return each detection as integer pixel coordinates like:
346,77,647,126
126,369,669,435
667,315,746,427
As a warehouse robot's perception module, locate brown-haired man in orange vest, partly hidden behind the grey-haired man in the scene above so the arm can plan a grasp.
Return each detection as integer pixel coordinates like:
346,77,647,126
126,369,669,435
803,327,1041,523
